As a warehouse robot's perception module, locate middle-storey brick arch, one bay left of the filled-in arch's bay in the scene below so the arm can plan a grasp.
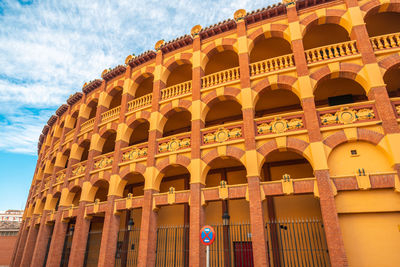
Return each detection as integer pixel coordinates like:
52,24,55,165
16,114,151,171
252,75,301,106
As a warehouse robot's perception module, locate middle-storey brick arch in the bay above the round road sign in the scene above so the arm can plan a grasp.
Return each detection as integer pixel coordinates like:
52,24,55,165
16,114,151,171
201,87,242,121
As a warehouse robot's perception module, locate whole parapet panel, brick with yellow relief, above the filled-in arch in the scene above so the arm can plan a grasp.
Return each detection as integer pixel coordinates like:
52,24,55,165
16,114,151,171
318,101,378,127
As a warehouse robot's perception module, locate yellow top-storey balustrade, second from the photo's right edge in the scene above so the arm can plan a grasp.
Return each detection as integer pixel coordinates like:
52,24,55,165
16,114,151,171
305,41,358,64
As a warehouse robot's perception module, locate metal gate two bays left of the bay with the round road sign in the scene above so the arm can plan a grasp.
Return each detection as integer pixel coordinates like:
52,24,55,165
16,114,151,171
115,227,140,267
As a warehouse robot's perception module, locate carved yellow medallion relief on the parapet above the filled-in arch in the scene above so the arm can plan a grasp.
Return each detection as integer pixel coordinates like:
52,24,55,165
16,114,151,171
320,107,375,125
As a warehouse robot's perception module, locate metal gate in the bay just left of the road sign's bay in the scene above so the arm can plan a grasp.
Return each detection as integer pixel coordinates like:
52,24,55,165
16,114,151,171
156,225,189,267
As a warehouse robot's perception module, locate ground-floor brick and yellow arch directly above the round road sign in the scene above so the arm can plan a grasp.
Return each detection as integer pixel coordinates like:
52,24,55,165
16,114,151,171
201,146,247,184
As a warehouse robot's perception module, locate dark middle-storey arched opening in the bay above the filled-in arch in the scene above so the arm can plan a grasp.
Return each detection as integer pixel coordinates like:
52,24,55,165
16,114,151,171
314,78,368,107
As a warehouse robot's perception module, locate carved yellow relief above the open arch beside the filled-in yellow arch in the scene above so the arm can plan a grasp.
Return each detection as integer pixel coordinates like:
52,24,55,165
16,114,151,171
257,117,304,134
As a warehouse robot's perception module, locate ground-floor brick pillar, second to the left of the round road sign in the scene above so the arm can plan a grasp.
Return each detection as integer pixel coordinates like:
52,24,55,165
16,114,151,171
138,189,157,267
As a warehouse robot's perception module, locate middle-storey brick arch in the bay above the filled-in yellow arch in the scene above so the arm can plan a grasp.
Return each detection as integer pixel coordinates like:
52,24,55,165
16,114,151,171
310,63,370,92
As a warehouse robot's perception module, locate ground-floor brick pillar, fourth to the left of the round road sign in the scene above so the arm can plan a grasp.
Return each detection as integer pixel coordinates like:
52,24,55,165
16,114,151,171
68,201,90,267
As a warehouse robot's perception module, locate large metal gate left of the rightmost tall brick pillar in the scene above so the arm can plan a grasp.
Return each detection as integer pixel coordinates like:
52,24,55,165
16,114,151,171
265,219,330,267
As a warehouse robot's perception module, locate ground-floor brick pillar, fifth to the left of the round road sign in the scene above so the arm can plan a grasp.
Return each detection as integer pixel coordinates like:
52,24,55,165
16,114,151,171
46,209,68,267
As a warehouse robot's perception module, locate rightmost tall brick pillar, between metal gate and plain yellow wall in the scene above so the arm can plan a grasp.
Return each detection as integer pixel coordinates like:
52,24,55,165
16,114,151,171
314,170,348,266
